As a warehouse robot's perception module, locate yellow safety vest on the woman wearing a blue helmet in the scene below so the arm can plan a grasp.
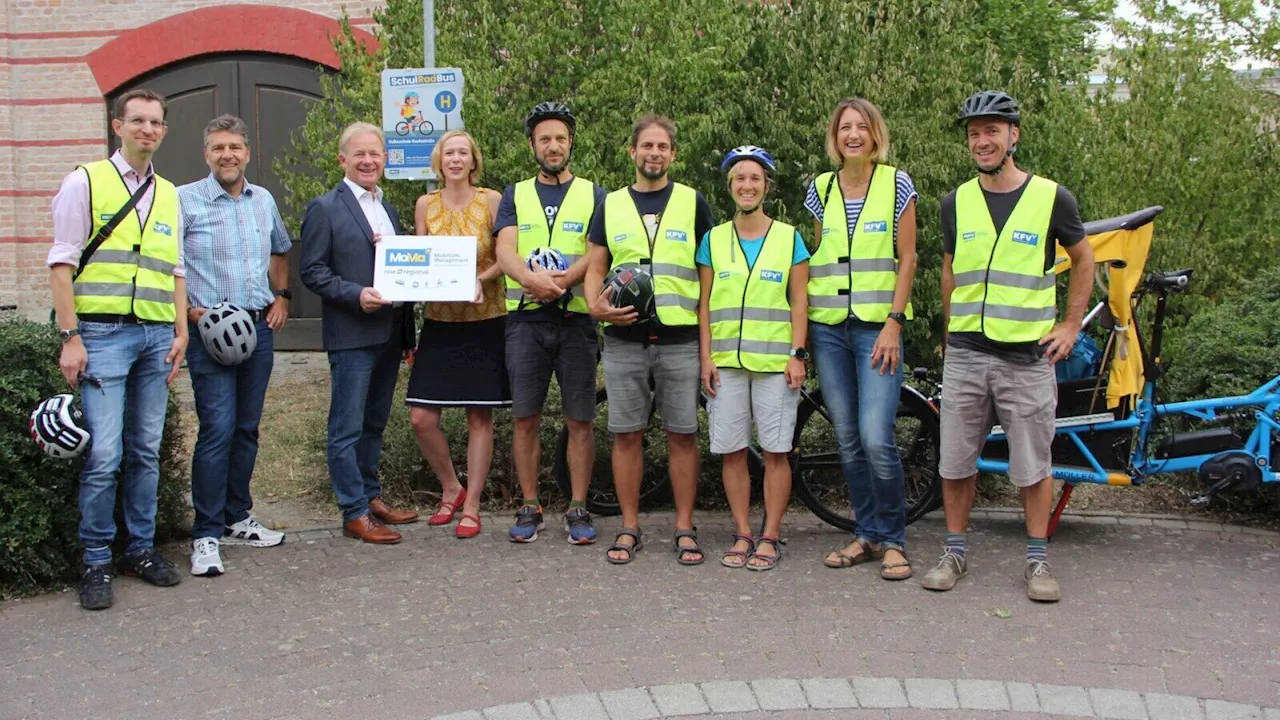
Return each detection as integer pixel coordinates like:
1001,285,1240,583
708,220,796,373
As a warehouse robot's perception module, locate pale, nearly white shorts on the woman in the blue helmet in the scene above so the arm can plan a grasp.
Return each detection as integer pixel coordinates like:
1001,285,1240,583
707,368,800,455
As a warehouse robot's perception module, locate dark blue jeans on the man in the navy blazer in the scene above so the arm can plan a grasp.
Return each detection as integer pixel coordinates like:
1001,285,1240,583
329,341,401,520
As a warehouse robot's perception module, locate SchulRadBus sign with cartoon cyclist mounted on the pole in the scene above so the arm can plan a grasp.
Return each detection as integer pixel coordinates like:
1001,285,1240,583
383,68,462,181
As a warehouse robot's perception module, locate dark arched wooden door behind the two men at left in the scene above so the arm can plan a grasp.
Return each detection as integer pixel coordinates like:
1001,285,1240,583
109,55,321,350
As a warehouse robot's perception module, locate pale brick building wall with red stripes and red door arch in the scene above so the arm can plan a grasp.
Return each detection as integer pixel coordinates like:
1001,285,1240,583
0,0,380,318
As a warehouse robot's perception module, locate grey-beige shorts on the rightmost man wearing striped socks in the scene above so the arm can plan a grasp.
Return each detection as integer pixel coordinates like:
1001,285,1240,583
938,346,1057,487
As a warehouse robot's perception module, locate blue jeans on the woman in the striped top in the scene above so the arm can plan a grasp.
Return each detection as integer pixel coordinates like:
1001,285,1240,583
809,319,906,550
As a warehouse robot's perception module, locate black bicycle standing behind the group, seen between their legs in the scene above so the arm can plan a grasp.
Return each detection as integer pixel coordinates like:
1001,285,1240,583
545,369,942,532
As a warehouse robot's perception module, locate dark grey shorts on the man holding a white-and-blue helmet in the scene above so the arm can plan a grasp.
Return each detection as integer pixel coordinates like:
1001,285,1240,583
507,319,595,423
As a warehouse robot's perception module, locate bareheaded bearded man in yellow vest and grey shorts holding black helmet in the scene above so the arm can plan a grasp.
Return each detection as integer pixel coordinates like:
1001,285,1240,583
586,115,716,565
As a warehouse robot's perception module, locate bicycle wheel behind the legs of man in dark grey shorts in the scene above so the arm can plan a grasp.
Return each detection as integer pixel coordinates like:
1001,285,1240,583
556,387,671,516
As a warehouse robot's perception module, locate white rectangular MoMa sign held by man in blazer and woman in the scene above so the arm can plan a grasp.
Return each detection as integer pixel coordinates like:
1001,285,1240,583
374,234,476,302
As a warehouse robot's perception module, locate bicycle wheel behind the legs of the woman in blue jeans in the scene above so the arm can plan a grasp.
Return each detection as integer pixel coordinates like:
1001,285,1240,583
792,386,942,533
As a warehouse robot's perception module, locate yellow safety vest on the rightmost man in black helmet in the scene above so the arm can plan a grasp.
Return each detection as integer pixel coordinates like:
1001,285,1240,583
947,176,1057,342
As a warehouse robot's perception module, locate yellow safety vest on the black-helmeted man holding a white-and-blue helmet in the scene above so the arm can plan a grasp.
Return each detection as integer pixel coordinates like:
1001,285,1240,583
507,177,595,315
